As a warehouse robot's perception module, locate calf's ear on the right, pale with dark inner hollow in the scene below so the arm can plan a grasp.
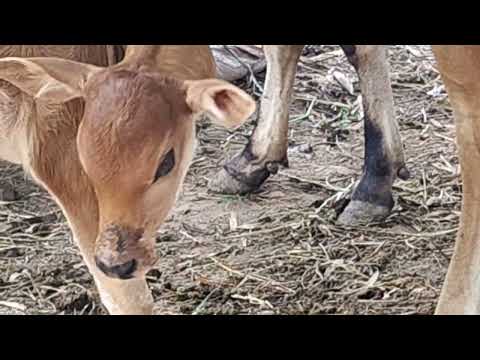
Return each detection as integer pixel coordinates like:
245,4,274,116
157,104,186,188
185,79,256,129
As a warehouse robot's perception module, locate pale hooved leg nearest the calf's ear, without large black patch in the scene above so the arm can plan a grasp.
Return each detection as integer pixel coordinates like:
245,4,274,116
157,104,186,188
209,45,304,194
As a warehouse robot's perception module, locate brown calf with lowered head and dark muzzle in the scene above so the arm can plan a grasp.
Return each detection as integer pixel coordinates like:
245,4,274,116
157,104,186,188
0,46,255,314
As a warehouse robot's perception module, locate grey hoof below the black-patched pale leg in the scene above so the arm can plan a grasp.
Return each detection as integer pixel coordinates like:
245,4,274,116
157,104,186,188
337,200,392,226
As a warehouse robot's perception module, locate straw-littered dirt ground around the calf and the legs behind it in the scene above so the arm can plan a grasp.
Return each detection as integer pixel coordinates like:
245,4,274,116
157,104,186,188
0,46,461,314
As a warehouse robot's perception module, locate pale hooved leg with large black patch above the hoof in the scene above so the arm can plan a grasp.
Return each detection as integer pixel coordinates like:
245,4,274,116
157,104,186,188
338,45,409,225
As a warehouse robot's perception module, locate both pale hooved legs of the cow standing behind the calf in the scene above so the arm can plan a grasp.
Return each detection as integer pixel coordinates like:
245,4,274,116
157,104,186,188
210,45,409,225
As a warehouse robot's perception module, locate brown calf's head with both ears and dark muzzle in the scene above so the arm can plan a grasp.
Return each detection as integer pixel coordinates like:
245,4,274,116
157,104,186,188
0,58,255,279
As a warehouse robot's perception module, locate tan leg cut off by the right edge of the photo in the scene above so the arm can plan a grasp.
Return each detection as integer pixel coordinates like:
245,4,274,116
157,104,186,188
433,45,480,314
